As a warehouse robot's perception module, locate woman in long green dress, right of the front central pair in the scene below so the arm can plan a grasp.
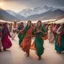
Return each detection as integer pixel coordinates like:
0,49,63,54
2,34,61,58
33,20,47,60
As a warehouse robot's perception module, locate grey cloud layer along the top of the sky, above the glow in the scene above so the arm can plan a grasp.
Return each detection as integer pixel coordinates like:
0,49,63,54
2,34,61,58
0,0,64,7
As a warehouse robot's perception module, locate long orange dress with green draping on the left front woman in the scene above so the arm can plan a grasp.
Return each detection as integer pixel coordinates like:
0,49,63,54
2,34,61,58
20,26,33,54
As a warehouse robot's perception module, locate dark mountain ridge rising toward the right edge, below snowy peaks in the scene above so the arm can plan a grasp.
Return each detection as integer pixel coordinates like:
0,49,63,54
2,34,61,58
26,9,64,20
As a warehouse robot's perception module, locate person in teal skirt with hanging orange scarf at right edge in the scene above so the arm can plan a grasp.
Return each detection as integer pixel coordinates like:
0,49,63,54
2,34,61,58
55,24,64,53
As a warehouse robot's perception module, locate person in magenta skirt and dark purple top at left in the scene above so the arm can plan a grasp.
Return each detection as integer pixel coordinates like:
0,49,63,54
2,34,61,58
2,23,12,51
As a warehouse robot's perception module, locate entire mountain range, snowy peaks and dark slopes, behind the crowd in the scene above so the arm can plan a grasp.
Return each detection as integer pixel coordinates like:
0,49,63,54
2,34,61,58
0,5,64,21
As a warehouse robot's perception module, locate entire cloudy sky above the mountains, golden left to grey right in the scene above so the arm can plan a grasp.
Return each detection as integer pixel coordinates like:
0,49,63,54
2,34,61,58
0,0,64,12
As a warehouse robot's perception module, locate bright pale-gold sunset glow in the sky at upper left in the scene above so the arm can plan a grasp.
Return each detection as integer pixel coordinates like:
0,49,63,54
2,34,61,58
0,1,27,12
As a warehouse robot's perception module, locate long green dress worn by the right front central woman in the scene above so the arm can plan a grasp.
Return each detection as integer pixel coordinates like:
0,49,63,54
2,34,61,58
33,27,47,56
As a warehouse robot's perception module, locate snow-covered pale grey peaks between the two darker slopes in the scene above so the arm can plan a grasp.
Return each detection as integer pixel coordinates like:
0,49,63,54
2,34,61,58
18,5,55,17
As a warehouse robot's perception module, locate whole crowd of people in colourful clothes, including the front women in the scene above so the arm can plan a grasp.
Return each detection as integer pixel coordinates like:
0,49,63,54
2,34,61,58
0,20,64,60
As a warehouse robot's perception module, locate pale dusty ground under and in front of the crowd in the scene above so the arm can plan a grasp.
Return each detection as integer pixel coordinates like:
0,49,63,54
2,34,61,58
0,37,64,64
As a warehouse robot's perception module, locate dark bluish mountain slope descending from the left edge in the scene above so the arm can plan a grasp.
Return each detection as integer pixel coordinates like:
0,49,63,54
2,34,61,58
0,8,19,21
